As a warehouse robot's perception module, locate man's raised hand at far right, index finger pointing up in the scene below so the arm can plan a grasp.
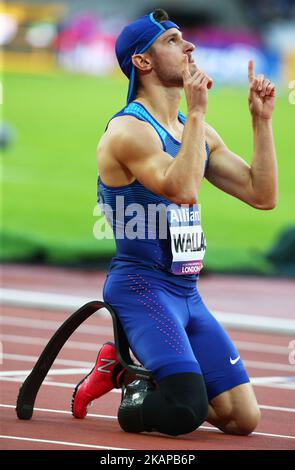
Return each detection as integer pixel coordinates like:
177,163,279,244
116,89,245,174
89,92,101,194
248,60,275,119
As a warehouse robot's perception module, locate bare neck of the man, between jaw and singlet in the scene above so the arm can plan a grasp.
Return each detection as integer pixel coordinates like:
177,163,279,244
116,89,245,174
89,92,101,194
135,87,180,129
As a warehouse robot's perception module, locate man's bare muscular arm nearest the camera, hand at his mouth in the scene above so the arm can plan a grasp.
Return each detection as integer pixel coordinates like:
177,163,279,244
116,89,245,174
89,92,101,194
112,57,210,204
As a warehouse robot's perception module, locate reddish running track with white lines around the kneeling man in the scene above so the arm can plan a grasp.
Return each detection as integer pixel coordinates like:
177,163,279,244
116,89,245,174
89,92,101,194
0,265,295,450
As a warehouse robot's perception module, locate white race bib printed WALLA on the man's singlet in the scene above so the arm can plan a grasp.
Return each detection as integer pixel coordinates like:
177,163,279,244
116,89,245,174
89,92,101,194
167,204,206,275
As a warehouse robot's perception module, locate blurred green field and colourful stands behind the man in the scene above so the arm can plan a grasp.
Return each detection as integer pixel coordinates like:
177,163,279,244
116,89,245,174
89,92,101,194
0,0,295,275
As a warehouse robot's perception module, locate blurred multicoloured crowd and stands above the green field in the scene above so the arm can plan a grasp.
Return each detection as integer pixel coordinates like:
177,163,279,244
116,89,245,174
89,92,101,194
0,0,295,85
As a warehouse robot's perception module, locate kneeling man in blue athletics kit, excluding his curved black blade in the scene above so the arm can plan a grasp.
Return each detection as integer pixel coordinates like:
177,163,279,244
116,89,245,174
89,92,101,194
72,10,277,435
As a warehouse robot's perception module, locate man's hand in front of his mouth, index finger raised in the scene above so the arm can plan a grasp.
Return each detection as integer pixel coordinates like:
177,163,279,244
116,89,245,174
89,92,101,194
182,55,212,114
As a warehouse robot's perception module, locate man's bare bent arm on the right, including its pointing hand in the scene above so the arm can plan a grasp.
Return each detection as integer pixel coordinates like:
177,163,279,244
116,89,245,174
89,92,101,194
206,61,278,210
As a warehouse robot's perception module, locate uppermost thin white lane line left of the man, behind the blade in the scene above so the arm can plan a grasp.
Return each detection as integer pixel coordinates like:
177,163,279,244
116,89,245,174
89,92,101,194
1,314,114,337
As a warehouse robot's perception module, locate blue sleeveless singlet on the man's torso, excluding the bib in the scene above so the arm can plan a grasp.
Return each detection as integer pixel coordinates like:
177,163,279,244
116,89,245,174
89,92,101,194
98,102,209,282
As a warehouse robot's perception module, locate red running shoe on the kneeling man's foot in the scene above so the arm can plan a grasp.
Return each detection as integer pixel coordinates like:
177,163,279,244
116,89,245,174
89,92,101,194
72,342,126,419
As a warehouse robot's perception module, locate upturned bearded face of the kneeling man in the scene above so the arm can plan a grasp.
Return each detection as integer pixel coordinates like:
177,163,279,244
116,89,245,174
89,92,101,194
152,28,197,86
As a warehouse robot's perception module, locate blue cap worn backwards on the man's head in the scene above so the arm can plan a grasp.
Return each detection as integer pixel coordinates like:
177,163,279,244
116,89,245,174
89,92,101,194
115,13,179,104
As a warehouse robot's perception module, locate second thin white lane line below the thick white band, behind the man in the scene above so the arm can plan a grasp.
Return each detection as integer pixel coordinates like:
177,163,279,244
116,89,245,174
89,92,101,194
1,334,295,372
